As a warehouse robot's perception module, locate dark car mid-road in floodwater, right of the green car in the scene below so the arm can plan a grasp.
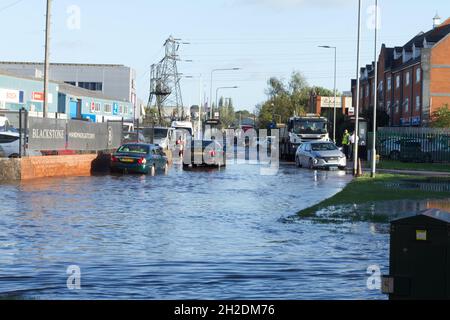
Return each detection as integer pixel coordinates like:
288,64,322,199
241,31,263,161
183,140,226,168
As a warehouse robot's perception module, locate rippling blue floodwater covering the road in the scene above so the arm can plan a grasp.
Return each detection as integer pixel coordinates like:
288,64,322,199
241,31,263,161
0,165,389,299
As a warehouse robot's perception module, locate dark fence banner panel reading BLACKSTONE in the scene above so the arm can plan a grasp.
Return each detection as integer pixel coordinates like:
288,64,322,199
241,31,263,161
28,118,66,150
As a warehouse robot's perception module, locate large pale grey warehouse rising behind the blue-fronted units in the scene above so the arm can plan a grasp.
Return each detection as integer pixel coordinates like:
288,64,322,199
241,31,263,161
0,61,137,115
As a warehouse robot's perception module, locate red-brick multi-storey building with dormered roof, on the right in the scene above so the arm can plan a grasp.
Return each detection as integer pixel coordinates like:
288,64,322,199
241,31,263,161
352,16,450,126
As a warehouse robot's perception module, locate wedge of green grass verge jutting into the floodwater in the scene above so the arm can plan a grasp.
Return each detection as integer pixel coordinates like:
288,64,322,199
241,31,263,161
298,174,450,217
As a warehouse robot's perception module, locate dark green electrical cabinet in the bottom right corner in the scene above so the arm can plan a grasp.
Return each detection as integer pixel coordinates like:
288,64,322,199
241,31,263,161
382,209,450,300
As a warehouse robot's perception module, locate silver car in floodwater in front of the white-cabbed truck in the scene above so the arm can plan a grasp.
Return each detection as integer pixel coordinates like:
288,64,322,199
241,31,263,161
295,142,347,170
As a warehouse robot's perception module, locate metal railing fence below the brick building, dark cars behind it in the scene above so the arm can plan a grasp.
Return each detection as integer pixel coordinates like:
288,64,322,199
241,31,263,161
369,128,450,162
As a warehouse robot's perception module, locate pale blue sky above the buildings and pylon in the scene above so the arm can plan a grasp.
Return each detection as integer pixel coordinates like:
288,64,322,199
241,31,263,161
0,0,450,111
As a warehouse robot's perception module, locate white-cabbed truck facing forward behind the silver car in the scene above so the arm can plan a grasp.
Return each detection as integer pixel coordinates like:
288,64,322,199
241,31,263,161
280,114,330,161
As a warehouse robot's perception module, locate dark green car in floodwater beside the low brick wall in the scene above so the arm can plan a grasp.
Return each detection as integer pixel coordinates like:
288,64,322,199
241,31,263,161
111,143,169,175
